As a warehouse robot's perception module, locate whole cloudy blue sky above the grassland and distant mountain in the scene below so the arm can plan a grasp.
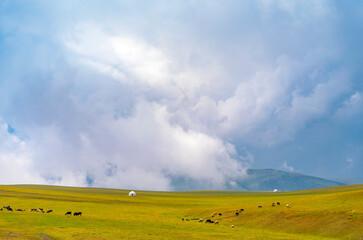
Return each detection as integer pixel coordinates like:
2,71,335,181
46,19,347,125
0,0,363,190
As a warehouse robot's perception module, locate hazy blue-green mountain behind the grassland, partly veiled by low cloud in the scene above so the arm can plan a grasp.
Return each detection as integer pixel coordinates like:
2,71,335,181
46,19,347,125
172,169,346,191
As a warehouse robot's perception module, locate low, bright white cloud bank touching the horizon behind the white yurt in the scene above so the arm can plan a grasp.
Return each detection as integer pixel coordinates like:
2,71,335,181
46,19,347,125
19,101,245,190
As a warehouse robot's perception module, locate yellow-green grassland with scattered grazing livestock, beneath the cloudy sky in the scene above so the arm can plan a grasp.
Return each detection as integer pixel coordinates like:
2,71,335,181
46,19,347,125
0,185,363,240
